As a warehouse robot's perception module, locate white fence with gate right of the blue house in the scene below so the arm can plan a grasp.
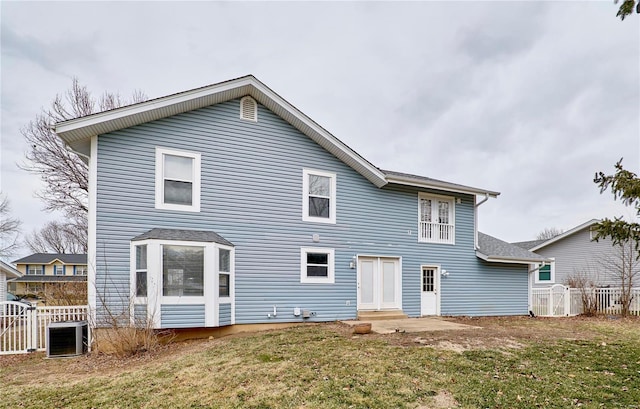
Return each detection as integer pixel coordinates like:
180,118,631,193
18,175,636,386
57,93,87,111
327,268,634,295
531,284,640,317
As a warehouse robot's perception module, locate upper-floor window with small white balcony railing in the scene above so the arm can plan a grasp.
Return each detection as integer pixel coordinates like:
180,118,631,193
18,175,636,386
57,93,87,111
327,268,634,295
418,193,456,244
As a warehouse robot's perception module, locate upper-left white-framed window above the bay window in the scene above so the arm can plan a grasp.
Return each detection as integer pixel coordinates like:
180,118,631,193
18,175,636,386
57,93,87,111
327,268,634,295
156,147,201,212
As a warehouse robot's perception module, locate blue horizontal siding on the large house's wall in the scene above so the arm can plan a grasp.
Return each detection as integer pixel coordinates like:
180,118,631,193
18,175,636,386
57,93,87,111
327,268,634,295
96,100,527,324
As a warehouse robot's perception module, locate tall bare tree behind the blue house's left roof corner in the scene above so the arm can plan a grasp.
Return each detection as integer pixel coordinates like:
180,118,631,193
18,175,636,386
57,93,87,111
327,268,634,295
20,78,147,248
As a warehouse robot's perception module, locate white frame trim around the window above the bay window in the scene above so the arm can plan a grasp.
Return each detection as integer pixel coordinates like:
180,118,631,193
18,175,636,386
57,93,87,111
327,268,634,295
155,146,201,212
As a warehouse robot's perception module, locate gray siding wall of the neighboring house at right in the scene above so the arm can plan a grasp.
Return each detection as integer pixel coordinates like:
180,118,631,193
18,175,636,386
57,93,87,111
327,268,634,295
533,227,640,288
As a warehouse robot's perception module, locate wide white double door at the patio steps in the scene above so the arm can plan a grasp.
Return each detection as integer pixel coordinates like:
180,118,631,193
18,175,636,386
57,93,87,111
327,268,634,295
358,257,402,310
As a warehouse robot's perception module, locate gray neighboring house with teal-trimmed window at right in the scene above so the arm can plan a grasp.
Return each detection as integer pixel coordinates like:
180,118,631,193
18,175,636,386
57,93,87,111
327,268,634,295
513,219,640,288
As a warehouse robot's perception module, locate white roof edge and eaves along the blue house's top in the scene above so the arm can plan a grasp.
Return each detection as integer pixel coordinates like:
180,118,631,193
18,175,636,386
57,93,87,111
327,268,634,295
54,75,499,197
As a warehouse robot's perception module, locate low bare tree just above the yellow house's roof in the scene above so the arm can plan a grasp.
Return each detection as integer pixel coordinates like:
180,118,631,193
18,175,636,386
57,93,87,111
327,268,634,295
24,221,87,254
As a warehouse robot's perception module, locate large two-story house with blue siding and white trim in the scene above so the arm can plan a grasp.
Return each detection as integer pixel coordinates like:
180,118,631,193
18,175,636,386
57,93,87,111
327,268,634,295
55,76,536,328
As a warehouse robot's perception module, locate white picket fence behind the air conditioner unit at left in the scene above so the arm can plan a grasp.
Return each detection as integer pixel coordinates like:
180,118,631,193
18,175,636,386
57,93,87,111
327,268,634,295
0,301,91,355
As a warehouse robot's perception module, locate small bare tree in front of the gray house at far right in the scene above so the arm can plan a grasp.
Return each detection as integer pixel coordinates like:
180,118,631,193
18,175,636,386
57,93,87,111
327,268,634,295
601,240,640,316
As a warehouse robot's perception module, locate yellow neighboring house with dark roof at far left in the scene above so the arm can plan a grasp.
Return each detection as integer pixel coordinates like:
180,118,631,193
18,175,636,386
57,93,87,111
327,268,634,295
9,253,88,295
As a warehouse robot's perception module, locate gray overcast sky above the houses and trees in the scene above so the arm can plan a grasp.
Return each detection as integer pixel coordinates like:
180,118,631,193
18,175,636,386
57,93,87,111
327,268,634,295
0,0,640,259
